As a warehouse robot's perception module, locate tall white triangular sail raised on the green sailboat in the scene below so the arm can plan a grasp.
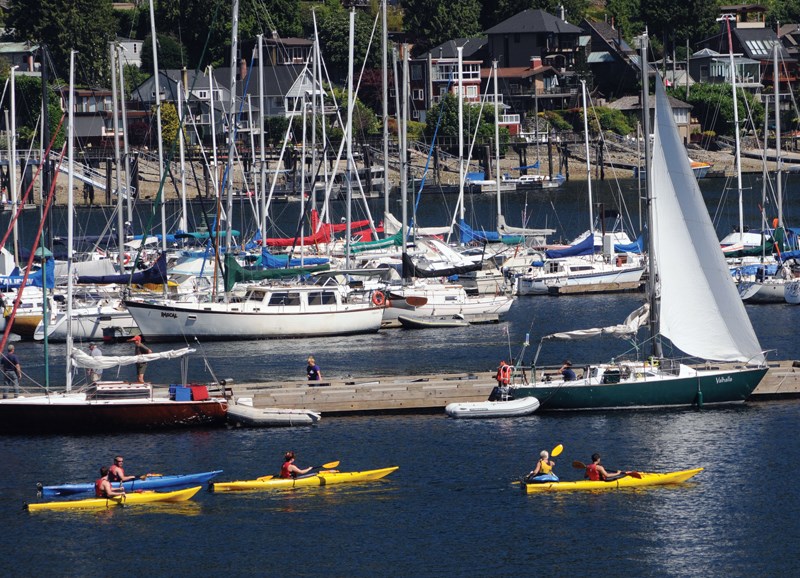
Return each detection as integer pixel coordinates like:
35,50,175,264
651,77,764,364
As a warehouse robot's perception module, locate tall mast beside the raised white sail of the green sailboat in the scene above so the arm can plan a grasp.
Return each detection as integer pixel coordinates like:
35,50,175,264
641,30,662,357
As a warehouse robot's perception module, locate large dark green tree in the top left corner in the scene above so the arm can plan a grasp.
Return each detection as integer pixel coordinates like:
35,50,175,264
6,0,116,85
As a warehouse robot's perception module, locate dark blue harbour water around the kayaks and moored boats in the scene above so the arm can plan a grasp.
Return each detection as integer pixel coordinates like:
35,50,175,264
0,172,800,576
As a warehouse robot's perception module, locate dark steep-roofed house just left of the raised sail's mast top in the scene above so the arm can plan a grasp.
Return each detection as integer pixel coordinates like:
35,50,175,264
581,20,639,99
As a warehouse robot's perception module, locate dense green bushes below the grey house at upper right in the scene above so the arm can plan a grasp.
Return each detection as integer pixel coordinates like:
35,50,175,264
668,84,764,135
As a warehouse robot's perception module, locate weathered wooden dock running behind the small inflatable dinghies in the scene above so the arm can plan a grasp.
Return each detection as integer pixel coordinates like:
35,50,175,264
223,361,800,416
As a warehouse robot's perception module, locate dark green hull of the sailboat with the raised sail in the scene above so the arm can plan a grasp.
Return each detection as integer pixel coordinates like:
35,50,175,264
512,368,767,411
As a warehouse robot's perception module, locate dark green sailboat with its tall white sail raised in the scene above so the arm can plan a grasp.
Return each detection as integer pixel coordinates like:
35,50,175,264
511,40,767,410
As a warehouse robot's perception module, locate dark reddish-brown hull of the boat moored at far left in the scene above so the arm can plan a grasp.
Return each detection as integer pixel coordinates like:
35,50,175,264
0,394,228,434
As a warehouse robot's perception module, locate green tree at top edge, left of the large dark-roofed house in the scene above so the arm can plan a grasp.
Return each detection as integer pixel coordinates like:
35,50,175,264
402,0,481,50
